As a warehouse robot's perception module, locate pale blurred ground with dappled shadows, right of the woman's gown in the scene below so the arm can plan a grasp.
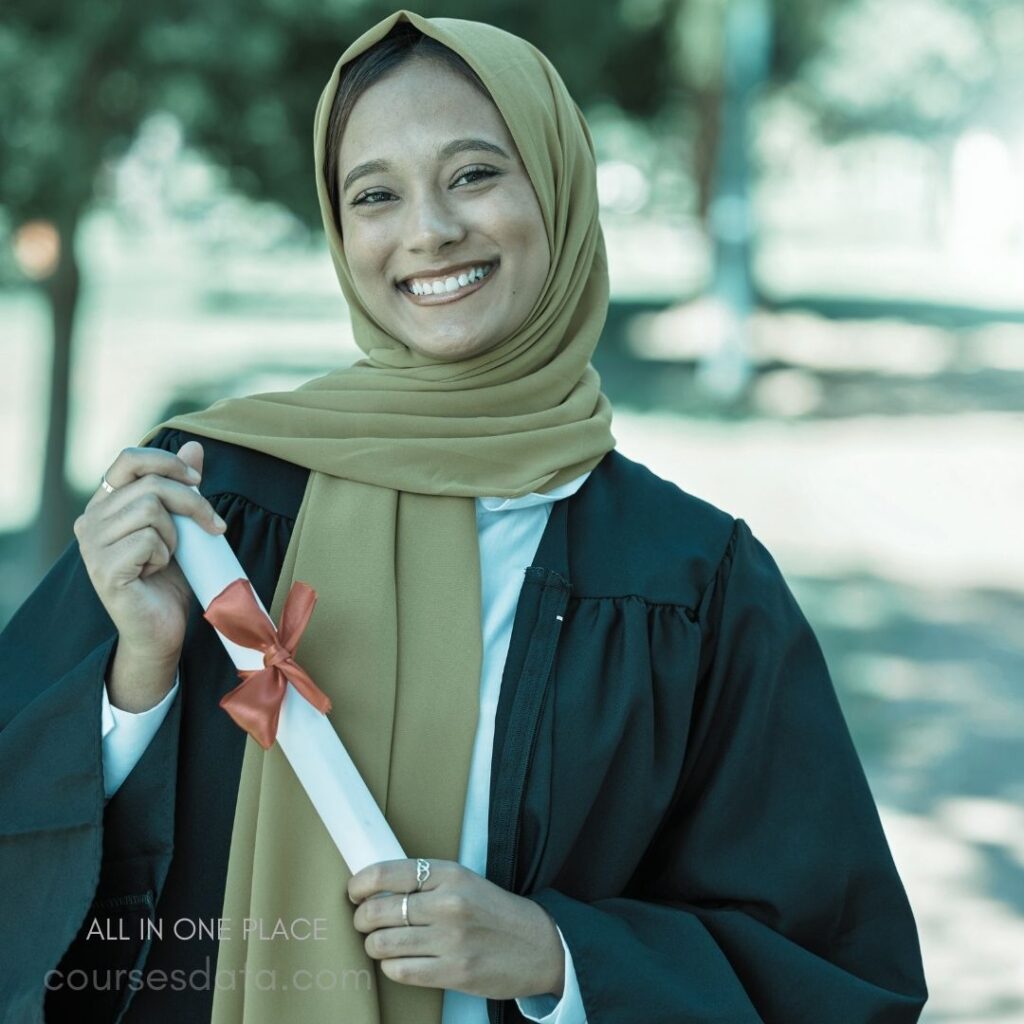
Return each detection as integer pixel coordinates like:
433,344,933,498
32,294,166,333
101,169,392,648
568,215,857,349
612,412,1024,1024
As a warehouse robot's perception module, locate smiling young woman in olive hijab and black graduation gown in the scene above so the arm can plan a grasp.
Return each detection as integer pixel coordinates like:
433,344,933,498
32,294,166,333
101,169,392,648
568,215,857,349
0,11,926,1024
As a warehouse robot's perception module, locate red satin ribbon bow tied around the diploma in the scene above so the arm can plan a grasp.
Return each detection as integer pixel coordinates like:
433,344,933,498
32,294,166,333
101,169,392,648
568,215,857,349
203,578,331,750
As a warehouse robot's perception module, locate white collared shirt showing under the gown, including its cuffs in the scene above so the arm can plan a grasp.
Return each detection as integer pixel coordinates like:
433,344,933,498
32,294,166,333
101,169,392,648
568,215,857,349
102,472,590,1024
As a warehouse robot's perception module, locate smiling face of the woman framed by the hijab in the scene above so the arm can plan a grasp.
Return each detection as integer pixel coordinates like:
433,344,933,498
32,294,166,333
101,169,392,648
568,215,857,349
338,58,550,361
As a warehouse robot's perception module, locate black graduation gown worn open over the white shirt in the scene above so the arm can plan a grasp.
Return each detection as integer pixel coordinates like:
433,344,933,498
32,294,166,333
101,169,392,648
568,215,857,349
0,430,927,1024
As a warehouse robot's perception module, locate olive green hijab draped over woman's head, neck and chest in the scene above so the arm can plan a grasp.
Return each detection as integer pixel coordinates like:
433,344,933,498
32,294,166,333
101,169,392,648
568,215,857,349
143,10,614,1024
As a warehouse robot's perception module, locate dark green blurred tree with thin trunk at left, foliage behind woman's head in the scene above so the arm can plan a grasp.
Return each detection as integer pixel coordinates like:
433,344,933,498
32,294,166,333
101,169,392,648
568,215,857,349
6,0,1007,565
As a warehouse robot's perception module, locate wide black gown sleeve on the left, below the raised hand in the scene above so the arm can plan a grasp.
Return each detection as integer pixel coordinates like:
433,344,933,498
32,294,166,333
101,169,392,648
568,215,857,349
0,434,188,1024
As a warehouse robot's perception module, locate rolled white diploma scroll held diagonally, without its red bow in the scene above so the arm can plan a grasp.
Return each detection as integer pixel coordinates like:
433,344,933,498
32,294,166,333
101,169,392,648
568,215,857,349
171,499,406,874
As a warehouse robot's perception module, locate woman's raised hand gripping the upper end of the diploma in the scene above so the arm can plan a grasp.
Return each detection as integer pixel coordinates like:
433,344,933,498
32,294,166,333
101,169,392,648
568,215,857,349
75,441,224,665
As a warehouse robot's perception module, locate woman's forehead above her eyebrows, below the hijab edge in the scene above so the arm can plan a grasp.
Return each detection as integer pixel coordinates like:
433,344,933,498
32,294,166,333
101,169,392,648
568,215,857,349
339,59,515,168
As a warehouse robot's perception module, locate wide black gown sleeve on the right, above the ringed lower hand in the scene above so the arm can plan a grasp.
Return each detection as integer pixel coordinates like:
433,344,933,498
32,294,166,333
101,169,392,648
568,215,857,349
529,519,928,1024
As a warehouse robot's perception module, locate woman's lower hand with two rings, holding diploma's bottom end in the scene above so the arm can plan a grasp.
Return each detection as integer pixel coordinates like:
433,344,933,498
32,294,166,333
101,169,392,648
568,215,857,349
348,859,565,999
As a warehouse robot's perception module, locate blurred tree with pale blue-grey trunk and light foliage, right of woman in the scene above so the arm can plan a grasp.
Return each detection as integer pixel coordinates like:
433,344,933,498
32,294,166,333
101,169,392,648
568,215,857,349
655,0,1024,400
